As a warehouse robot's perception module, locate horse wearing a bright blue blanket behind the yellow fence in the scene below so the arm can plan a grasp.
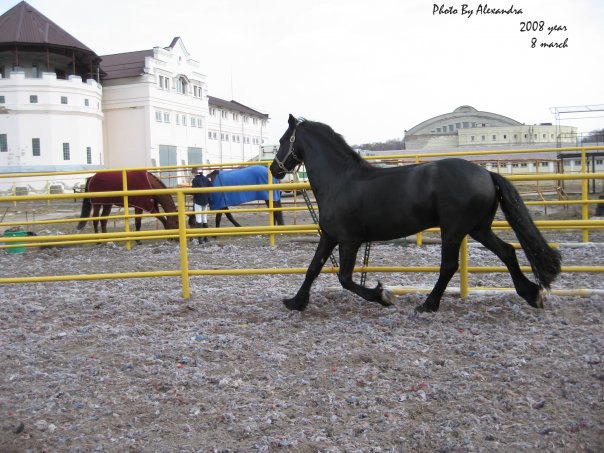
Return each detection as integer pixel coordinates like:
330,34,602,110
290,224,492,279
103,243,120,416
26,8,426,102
208,165,284,228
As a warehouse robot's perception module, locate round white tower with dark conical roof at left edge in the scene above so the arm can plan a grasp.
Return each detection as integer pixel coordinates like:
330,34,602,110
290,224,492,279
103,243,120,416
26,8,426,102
0,2,103,190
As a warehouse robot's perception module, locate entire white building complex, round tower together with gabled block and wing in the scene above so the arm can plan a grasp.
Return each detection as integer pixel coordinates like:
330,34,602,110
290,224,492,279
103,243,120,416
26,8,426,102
0,2,268,190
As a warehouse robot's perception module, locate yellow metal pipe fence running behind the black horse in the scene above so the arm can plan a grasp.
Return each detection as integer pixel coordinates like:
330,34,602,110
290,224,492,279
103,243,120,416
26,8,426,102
0,147,604,299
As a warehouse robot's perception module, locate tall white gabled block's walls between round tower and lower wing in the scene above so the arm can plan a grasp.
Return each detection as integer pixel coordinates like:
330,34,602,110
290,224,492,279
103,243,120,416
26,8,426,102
103,39,208,173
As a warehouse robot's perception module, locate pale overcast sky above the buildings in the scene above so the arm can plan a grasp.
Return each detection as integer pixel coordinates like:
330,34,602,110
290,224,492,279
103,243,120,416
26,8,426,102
0,0,604,145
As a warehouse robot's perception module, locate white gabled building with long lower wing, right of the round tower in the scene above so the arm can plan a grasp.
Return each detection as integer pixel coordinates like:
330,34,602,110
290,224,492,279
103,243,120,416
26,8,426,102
101,37,268,182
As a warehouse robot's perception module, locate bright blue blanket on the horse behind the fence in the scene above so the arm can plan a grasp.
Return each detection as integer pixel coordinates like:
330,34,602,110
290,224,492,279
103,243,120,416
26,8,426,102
210,165,281,209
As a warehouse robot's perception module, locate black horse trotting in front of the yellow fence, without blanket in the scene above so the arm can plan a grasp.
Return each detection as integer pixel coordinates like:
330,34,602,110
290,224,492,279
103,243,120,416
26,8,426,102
270,115,561,312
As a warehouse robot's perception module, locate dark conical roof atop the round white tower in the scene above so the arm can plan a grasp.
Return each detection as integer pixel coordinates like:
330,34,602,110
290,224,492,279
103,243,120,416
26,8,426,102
0,2,94,54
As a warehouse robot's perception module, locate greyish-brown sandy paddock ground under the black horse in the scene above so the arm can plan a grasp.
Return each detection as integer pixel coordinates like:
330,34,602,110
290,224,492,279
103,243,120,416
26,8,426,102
0,210,604,452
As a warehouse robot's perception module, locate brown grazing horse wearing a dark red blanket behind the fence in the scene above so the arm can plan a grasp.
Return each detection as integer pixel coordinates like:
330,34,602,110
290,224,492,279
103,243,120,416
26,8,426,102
77,170,178,238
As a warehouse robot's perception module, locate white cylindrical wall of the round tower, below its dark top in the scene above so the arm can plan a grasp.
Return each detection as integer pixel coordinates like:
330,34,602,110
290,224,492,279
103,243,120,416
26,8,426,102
0,68,104,191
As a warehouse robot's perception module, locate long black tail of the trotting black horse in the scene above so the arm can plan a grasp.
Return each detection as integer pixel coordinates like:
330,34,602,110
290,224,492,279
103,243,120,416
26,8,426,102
491,173,562,289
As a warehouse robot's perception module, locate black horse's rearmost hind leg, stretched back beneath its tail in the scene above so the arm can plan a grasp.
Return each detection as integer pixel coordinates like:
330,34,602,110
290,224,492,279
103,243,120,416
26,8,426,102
470,228,543,308
